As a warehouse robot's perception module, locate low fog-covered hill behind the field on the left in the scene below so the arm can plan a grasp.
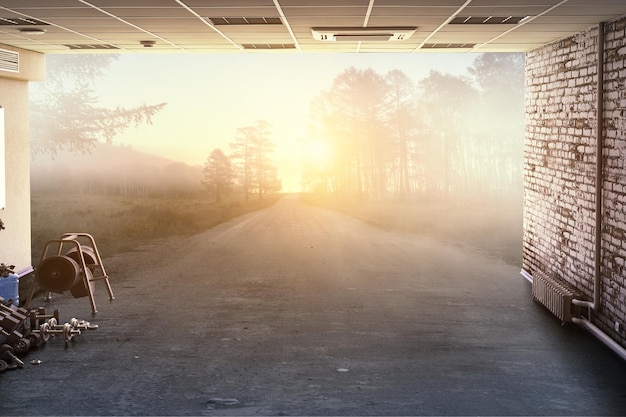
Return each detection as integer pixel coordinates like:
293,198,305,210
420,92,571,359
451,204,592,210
31,143,203,196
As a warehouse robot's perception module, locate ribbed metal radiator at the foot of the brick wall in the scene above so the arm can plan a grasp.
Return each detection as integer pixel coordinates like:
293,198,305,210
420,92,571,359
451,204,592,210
532,271,580,323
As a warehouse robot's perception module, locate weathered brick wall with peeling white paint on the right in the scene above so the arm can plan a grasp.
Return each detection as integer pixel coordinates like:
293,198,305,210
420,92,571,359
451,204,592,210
522,17,626,346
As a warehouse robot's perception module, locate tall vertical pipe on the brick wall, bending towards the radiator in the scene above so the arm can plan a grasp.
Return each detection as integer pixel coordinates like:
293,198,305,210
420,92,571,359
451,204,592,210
572,22,604,310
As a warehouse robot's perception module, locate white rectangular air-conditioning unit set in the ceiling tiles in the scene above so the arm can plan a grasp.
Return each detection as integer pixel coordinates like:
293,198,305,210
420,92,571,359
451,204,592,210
311,27,417,42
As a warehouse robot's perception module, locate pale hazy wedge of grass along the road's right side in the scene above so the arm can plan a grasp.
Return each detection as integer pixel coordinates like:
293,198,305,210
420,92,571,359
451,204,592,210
301,195,522,265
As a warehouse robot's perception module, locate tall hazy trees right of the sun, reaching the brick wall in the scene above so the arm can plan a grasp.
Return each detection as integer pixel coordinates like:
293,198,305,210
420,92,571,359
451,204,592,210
303,54,524,200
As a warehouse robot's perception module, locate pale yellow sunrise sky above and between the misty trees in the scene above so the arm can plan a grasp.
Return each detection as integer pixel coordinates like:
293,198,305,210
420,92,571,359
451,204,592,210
94,53,477,191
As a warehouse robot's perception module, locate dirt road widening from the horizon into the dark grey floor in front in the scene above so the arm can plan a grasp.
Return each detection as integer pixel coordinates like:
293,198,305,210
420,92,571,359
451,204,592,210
0,197,626,415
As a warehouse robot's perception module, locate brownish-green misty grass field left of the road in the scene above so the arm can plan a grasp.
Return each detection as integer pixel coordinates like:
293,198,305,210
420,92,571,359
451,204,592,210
31,193,278,265
